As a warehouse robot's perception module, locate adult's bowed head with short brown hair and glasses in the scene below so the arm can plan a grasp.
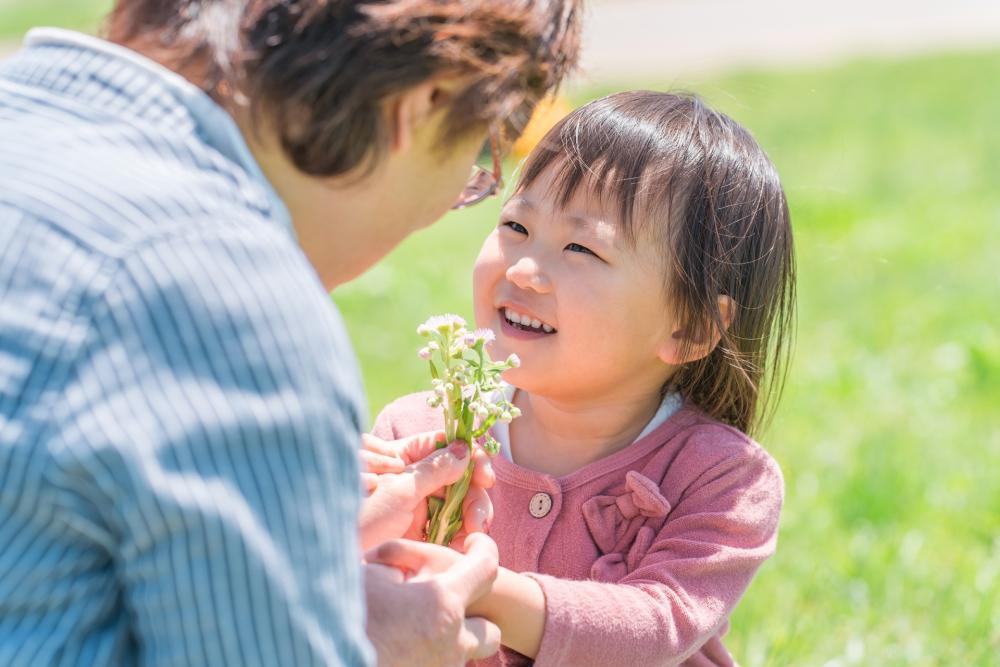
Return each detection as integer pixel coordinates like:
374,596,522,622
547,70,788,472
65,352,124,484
107,0,582,289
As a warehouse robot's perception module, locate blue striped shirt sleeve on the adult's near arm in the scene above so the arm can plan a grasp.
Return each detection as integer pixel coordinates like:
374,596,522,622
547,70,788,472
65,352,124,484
52,226,373,666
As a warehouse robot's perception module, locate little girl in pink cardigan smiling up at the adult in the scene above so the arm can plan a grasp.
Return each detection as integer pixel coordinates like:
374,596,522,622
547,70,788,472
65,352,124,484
374,92,794,667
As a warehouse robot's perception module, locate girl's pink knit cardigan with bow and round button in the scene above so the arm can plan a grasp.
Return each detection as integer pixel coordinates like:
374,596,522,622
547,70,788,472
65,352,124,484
373,394,783,667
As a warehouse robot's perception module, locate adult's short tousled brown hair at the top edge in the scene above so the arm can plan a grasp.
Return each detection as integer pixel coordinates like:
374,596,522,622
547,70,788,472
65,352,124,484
106,0,582,176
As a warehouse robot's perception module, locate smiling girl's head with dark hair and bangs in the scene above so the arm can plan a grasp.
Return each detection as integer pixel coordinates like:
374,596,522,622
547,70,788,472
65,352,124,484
475,92,795,432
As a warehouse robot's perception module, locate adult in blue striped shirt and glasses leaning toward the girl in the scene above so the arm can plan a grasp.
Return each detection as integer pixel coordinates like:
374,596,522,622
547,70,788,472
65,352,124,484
0,0,579,665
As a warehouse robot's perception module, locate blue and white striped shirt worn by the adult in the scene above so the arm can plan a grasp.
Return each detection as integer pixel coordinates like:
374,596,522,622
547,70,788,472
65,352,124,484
0,31,372,666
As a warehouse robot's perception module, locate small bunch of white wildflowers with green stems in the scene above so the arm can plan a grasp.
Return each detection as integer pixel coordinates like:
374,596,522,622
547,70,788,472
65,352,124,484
417,315,521,545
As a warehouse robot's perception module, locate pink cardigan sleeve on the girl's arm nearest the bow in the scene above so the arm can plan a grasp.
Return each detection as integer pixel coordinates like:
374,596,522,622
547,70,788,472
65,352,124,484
516,450,783,667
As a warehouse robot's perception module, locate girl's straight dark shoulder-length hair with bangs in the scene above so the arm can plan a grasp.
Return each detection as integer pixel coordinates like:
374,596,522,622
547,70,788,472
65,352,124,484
517,91,795,434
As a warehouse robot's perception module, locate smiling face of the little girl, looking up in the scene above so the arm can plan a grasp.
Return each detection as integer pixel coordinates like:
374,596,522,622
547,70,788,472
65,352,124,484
473,168,677,399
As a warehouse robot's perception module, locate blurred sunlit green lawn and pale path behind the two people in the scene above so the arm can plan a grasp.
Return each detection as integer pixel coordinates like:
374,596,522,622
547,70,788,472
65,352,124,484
0,0,1000,667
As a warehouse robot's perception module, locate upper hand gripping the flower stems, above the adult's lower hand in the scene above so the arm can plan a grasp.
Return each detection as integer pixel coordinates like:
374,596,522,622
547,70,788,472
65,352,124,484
360,431,495,549
